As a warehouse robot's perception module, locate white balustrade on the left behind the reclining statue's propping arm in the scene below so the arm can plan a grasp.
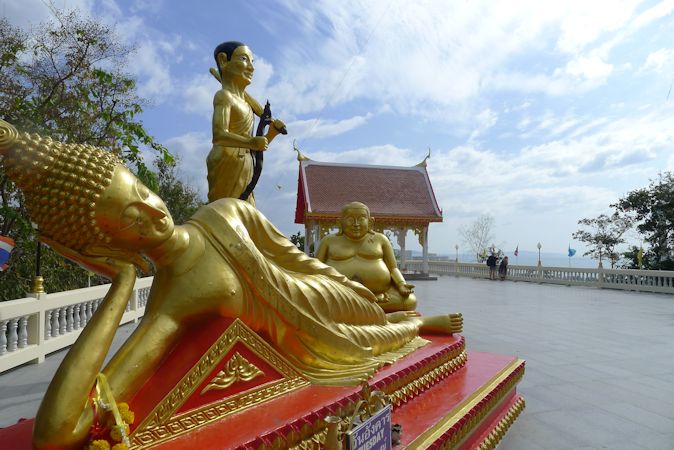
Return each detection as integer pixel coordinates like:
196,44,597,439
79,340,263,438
0,277,152,373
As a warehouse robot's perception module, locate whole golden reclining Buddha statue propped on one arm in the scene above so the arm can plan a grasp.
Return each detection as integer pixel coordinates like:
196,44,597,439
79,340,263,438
0,121,462,448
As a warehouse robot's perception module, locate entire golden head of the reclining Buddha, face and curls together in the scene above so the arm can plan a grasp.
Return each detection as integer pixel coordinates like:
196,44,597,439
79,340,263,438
0,120,173,255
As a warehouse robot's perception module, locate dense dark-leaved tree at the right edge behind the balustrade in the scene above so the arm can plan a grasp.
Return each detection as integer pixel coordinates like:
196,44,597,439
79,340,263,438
611,172,674,270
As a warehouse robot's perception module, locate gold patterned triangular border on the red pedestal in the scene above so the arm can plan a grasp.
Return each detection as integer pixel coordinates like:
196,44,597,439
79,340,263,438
130,319,309,448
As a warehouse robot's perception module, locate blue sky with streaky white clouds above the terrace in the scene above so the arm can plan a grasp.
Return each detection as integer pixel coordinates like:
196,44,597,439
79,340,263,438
5,0,674,260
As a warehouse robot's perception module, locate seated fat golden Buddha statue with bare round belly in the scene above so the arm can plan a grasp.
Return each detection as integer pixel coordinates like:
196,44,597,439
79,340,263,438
316,202,417,312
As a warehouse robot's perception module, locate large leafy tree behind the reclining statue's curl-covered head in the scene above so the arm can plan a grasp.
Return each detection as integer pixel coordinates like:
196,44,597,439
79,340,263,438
0,11,171,300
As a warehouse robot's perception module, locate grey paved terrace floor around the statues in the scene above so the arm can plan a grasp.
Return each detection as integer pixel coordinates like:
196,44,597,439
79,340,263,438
0,277,674,450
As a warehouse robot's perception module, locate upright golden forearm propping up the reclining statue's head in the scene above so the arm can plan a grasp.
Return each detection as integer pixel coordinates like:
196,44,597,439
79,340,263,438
33,261,136,449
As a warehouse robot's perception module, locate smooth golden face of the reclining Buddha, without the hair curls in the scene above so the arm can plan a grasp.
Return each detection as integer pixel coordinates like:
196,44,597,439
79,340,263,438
96,165,174,250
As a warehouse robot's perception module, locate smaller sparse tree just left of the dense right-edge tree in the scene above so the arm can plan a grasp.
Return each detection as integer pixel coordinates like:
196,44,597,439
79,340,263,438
573,212,633,267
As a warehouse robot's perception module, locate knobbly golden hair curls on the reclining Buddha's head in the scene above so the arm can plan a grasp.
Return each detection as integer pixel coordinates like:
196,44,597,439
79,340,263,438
0,120,122,251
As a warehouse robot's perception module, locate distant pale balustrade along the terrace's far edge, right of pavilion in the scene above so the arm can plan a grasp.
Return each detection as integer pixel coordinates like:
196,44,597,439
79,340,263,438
407,260,674,294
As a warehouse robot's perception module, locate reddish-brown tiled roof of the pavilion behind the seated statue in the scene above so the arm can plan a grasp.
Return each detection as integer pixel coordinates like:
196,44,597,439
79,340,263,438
295,160,442,223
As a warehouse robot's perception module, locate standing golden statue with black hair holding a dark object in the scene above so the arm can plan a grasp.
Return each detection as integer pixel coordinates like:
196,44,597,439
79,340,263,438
206,41,285,205
